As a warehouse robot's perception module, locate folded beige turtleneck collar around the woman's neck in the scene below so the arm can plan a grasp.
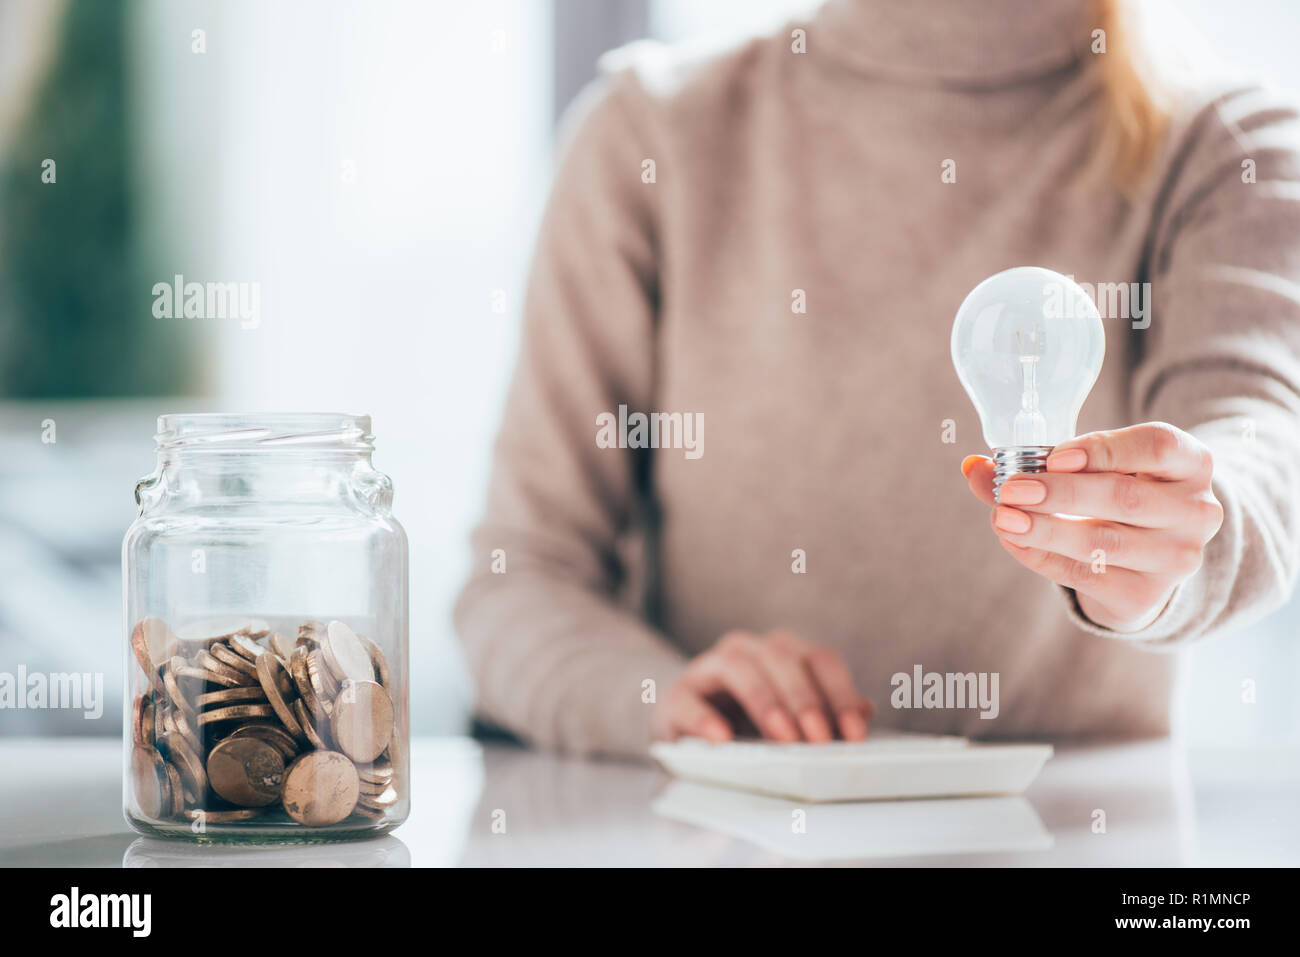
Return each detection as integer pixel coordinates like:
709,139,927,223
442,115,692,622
809,0,1099,87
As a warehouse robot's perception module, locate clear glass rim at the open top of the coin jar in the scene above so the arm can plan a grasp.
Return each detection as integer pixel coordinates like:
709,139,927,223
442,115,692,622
153,412,374,451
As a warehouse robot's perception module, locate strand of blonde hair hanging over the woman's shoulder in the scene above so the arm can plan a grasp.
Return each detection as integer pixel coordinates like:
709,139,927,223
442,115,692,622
1091,0,1175,195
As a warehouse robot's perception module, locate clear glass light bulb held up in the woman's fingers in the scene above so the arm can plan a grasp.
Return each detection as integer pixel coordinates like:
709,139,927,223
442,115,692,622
953,265,1106,498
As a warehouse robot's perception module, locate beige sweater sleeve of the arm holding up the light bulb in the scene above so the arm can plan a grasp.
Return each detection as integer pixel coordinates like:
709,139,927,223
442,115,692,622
1070,90,1300,649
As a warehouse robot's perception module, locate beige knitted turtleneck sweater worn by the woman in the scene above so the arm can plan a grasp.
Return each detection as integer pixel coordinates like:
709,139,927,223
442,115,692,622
456,0,1300,754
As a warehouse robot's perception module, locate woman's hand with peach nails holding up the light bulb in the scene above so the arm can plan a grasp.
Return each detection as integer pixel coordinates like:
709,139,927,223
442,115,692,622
962,423,1223,632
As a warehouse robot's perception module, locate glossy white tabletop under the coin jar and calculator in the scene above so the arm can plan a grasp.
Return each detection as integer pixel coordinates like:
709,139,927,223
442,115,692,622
0,739,1300,867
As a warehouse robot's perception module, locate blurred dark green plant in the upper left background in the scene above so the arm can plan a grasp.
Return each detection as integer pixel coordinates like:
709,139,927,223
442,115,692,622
0,0,192,399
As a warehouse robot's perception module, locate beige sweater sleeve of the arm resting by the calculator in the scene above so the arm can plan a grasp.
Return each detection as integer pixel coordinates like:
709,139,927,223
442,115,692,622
455,77,684,754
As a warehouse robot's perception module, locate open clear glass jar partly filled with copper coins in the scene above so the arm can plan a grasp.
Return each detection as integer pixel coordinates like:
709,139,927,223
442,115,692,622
122,412,411,843
